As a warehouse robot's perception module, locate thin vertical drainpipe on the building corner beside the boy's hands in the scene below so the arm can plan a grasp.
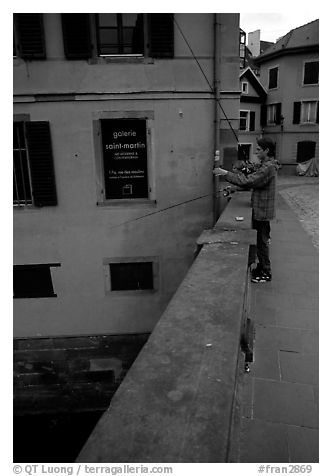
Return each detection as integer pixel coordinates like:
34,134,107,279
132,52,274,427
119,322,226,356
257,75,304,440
213,13,221,223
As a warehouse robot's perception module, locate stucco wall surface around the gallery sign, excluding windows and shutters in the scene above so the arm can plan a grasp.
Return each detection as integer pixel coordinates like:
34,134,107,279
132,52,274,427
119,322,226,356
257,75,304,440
14,14,238,337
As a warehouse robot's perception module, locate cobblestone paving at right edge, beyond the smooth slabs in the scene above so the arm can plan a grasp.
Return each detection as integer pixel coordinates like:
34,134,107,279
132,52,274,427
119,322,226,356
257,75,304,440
278,176,319,248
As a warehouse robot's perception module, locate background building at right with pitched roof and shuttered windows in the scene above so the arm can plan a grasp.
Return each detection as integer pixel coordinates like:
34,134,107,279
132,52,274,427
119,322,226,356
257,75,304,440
255,20,319,174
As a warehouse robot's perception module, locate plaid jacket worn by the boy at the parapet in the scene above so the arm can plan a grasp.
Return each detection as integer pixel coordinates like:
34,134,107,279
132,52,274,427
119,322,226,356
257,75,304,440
225,158,277,221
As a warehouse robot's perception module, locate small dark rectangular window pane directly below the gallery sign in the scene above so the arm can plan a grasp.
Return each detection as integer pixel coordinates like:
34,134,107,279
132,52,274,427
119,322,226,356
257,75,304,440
110,261,153,291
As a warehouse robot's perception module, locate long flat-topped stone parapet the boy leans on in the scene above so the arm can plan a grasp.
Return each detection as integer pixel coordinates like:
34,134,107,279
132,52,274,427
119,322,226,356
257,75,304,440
77,192,256,463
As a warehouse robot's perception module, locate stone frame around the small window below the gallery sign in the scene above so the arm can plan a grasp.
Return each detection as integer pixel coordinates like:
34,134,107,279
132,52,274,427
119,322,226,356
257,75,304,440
103,256,160,297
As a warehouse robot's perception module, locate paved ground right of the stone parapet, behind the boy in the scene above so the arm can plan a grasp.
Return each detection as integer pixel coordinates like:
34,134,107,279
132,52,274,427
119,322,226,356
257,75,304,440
238,184,319,463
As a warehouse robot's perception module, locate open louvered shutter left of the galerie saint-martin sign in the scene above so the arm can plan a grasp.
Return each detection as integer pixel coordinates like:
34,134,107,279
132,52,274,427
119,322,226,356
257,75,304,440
25,122,58,207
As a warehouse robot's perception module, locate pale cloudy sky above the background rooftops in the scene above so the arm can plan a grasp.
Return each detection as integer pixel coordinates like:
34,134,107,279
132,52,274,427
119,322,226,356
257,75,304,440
240,9,319,42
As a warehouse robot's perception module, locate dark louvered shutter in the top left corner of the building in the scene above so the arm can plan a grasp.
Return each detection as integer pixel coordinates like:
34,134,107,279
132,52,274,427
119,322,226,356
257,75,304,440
14,13,46,60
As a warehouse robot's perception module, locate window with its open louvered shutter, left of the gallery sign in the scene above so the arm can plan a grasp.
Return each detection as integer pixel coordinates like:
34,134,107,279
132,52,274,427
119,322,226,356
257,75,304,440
13,122,57,207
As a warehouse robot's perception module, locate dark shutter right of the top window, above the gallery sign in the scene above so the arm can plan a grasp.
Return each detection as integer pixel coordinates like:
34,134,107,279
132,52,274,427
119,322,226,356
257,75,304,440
149,13,174,58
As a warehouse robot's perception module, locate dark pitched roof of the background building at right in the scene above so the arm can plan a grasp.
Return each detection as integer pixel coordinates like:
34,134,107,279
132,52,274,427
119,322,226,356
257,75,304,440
255,20,319,63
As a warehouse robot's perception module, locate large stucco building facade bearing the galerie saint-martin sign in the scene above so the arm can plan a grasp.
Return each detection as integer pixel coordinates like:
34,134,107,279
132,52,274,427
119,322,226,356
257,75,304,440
14,13,239,338
